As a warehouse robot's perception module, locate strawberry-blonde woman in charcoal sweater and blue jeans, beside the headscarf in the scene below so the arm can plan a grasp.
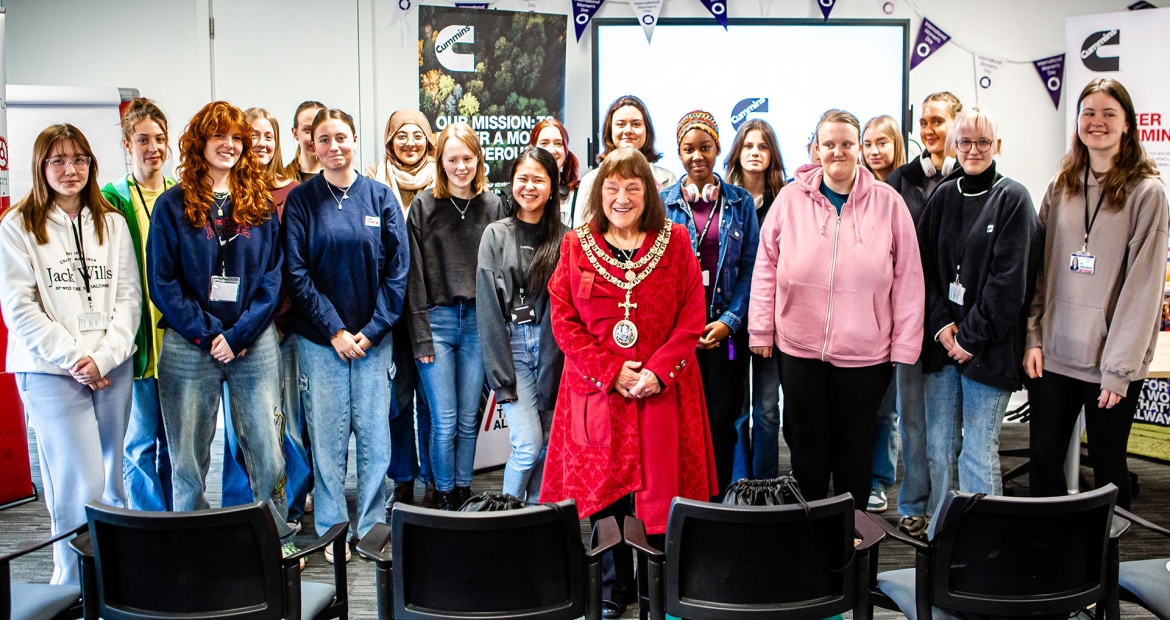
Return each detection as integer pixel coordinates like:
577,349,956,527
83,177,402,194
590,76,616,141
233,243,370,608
406,123,504,510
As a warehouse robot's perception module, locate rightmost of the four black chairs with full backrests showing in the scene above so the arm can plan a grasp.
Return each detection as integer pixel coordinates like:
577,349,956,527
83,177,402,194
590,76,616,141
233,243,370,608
869,484,1129,620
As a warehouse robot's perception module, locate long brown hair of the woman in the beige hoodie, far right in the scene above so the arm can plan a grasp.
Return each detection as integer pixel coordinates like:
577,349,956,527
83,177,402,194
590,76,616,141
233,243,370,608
1055,77,1159,211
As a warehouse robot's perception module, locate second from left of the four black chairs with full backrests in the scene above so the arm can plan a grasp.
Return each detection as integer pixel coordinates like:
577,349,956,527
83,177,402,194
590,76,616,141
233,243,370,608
358,501,621,620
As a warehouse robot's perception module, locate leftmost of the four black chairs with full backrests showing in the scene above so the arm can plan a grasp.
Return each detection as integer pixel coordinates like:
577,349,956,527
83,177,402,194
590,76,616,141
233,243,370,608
73,502,349,620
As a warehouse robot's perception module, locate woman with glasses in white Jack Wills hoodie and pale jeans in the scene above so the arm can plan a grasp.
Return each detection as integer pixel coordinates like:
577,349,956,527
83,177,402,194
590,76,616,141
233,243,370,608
0,125,143,585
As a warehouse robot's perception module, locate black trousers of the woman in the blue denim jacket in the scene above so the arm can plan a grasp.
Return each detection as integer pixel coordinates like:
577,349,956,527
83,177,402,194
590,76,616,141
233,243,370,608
695,329,751,498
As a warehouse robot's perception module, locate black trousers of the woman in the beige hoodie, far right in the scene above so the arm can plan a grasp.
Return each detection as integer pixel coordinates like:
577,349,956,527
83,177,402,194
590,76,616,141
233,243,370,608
1027,372,1142,510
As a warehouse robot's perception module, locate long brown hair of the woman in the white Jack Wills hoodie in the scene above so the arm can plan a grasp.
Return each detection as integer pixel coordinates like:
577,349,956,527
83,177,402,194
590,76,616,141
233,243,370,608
5,124,121,246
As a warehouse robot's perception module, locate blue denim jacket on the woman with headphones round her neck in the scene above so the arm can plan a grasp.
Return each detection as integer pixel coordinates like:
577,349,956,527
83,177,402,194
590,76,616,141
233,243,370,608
661,174,759,332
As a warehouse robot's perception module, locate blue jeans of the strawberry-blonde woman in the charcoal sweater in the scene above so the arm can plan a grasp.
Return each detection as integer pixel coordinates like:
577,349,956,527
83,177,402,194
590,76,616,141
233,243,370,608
418,301,483,491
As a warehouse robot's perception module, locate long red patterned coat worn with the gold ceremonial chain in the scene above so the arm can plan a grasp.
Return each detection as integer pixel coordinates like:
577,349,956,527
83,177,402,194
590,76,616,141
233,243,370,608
541,223,718,533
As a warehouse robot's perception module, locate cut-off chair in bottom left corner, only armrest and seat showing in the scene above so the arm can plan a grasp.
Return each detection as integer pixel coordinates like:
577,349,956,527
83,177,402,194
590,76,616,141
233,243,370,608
0,525,85,620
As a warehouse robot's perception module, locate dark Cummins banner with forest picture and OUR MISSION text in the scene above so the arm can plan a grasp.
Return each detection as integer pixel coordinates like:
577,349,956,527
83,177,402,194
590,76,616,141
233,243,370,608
419,6,567,188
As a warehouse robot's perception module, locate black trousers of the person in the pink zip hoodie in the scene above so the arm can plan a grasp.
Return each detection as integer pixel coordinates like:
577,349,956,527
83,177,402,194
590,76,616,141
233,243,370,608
779,352,894,500
